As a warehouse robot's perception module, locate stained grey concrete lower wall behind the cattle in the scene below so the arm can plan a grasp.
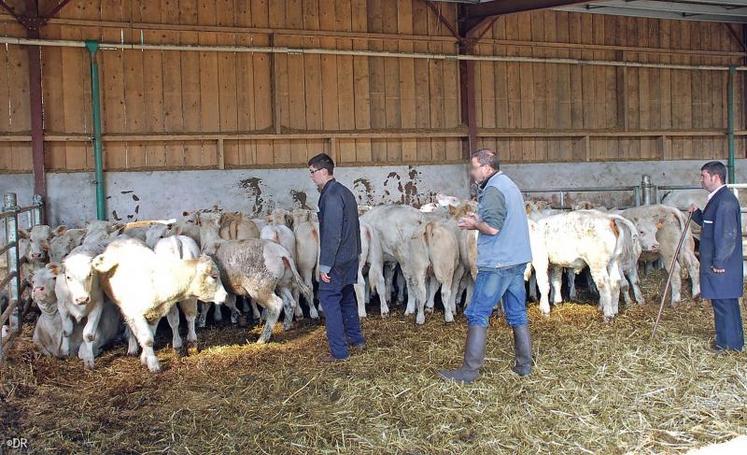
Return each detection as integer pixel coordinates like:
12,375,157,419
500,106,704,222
0,159,747,232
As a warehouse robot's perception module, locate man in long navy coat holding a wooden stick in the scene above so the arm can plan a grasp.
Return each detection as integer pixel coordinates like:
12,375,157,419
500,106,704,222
690,161,744,351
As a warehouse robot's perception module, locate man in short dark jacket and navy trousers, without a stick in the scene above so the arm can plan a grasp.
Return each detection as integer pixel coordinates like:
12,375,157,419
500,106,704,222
309,153,365,361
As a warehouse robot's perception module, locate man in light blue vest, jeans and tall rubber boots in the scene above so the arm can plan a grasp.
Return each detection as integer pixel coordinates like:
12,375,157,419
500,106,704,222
438,149,532,383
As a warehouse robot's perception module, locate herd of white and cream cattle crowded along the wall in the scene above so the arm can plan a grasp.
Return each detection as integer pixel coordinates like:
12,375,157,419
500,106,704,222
0,195,700,372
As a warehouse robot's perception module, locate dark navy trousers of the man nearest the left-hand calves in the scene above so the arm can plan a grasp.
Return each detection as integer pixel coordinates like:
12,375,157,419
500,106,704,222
319,282,365,359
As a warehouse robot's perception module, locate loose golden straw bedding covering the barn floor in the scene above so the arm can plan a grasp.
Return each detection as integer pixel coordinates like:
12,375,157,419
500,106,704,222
0,273,747,454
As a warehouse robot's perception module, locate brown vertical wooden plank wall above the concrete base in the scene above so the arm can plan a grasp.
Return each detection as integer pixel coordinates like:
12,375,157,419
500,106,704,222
0,0,744,172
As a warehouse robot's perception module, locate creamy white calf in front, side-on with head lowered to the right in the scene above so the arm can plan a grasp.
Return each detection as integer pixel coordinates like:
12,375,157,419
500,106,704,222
92,239,226,372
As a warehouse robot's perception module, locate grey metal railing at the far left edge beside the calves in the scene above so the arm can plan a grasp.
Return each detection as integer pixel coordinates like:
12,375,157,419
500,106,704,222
0,193,44,361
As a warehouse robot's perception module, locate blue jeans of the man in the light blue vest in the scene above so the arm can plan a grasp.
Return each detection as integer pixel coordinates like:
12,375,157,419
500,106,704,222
464,264,527,327
